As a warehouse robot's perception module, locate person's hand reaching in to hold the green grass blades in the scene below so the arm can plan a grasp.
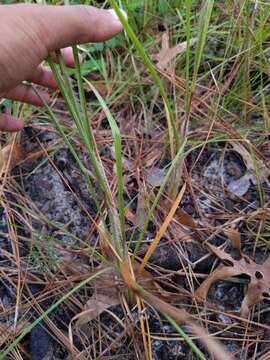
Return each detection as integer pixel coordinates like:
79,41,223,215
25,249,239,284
0,4,122,132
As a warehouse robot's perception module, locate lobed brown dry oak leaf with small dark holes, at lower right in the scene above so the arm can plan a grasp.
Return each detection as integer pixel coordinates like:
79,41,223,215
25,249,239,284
195,244,270,318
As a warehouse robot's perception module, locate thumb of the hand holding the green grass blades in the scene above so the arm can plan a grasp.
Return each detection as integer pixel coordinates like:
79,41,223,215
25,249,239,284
33,5,123,51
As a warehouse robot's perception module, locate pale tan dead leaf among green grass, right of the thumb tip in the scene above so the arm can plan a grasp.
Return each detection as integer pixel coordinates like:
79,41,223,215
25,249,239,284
155,31,197,70
